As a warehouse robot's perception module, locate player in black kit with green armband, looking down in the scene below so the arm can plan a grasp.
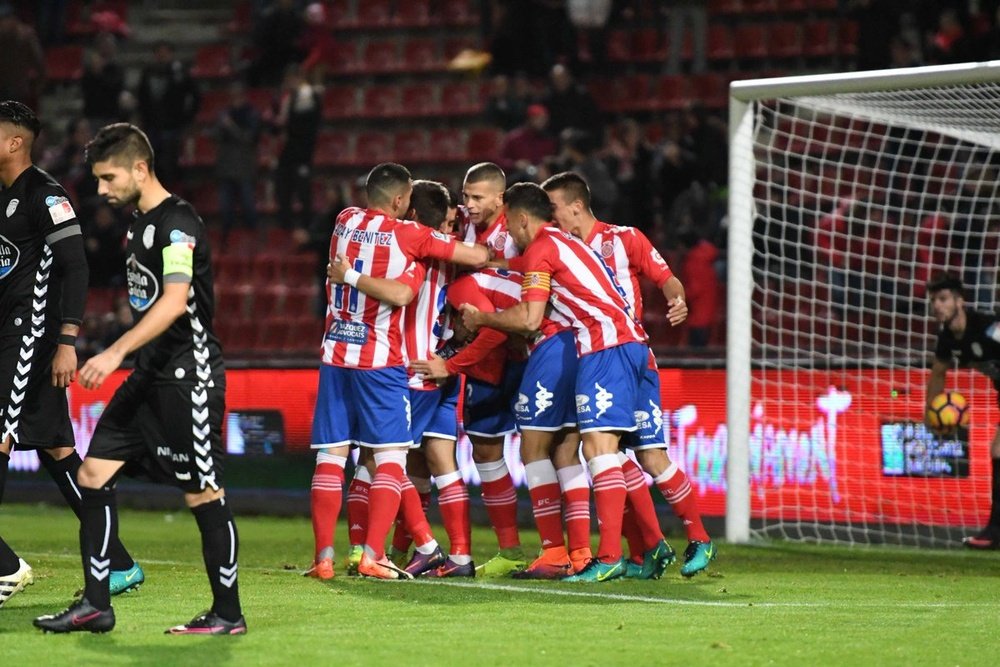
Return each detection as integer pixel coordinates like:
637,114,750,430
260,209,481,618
35,123,247,635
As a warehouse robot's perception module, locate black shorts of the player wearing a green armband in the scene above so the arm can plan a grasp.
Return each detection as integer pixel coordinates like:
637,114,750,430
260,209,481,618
87,373,226,493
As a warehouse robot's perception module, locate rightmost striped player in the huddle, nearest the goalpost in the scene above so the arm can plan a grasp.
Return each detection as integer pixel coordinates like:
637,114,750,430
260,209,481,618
542,172,715,576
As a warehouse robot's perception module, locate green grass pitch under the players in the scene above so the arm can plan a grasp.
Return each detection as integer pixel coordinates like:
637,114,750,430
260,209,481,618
0,505,1000,667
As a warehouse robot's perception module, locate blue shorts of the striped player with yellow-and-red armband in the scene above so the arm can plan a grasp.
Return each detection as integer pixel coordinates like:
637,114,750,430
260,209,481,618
576,343,649,433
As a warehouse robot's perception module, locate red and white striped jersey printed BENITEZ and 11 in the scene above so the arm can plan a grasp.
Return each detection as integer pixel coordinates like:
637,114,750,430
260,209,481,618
323,207,456,369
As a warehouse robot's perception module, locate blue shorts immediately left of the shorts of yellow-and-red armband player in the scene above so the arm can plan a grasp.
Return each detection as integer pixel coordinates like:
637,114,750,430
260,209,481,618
514,331,578,431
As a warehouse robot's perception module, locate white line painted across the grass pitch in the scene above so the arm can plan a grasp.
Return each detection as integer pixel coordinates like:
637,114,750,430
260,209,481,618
24,551,996,609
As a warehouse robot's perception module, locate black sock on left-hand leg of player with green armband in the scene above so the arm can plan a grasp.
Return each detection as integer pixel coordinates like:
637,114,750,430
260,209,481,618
80,487,118,610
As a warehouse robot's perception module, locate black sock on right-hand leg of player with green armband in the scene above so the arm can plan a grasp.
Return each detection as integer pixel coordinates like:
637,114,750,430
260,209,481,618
191,498,243,621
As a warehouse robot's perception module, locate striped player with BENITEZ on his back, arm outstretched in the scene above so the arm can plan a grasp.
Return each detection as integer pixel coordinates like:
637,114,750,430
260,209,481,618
313,163,488,578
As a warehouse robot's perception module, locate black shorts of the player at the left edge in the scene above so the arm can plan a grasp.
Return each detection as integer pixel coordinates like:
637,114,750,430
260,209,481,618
0,335,76,449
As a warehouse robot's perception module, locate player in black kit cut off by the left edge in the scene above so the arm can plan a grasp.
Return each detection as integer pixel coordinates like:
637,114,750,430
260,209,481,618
0,101,143,606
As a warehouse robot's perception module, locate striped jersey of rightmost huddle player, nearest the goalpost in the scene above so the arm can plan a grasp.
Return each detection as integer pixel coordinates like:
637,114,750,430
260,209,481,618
584,220,674,322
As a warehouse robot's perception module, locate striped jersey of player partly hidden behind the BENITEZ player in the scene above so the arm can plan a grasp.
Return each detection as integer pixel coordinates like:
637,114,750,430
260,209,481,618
403,261,455,390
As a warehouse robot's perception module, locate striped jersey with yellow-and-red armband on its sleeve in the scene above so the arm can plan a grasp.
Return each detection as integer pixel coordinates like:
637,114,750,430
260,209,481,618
521,227,646,355
